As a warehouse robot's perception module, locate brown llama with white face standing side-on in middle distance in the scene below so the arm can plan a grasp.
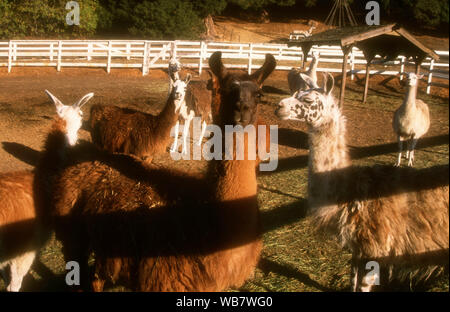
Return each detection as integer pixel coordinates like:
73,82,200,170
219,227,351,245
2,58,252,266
89,76,190,162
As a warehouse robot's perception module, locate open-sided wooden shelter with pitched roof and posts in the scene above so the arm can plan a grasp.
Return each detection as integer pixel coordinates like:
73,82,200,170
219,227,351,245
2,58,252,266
288,24,439,106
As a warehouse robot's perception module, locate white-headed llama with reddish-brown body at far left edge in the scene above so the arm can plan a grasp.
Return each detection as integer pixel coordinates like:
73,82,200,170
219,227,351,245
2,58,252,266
0,90,93,291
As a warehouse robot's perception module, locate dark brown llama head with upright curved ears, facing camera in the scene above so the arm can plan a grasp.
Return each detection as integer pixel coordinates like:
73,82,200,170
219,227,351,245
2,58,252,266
209,51,276,127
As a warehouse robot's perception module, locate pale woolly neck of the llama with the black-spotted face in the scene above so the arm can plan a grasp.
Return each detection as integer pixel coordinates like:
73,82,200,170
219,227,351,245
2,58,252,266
308,109,351,208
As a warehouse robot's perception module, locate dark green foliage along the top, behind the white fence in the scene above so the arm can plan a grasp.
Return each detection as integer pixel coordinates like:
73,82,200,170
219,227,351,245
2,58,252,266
0,0,449,39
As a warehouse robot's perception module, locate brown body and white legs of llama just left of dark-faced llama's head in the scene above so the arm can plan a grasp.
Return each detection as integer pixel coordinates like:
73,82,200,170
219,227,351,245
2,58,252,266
171,71,213,153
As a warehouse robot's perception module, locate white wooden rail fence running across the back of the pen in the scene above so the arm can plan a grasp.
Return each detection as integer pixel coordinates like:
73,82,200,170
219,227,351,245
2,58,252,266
0,40,449,93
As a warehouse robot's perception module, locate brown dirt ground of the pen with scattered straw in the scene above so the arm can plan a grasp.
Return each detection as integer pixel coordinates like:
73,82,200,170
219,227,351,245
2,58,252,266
0,64,449,291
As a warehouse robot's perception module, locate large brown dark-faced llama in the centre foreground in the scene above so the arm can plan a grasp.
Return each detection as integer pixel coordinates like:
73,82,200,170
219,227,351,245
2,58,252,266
48,52,276,291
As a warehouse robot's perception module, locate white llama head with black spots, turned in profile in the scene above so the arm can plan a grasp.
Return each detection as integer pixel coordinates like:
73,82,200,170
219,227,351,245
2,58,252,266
275,73,338,127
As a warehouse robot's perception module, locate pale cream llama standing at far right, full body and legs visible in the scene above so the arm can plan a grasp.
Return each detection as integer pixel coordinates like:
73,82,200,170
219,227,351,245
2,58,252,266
392,73,430,167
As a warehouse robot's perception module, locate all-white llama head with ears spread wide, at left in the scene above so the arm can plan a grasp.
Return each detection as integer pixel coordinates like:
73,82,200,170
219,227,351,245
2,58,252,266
45,90,94,145
